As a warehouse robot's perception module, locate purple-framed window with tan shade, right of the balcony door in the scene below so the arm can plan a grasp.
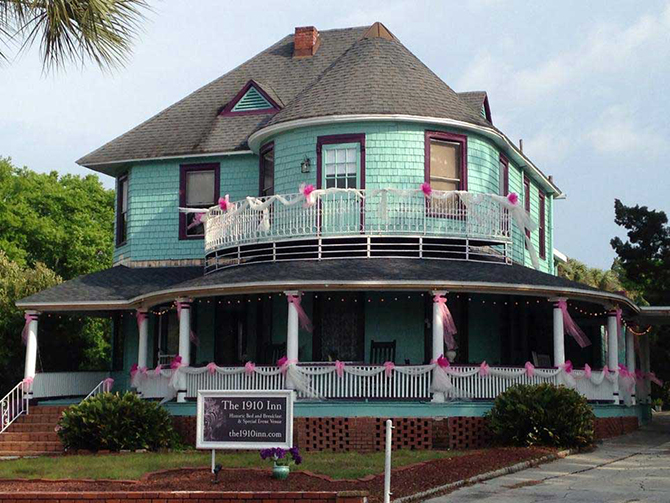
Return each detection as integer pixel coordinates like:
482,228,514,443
425,131,468,190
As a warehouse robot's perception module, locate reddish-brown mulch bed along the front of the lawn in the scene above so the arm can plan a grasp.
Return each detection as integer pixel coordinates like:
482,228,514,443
0,448,555,503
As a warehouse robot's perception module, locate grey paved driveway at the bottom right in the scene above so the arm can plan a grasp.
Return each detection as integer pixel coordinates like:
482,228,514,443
428,412,670,503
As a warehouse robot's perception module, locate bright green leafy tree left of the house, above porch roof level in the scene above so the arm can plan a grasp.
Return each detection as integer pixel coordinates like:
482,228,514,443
0,158,114,280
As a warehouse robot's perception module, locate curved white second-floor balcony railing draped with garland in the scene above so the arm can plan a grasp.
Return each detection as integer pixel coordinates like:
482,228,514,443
205,189,523,272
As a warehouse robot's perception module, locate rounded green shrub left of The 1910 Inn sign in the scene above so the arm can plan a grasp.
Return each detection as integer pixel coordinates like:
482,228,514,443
56,393,179,451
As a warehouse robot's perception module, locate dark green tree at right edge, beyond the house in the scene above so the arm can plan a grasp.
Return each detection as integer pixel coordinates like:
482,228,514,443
610,199,670,388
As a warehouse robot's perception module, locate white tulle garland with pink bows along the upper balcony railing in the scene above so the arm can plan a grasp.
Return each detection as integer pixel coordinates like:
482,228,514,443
179,184,540,269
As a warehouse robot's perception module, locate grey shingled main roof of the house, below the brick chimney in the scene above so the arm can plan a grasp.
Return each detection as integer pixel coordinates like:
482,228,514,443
77,23,498,173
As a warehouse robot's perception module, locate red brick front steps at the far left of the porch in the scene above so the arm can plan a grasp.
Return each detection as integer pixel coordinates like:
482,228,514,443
0,405,67,457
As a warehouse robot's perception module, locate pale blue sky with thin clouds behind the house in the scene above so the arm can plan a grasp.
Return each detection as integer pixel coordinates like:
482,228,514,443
0,0,670,268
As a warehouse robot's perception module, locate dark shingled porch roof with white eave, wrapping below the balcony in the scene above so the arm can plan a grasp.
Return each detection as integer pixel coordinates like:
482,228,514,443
17,259,639,313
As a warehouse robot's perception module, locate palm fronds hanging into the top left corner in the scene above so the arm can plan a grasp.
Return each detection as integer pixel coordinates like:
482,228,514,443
0,0,148,71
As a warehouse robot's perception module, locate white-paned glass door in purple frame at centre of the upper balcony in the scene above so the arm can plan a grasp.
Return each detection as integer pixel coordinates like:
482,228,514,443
316,134,365,189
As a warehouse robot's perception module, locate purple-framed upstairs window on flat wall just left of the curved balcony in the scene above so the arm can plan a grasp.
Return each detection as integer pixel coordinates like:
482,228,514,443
179,164,220,239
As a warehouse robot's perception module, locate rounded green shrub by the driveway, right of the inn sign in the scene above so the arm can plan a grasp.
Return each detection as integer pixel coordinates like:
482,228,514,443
487,384,594,447
